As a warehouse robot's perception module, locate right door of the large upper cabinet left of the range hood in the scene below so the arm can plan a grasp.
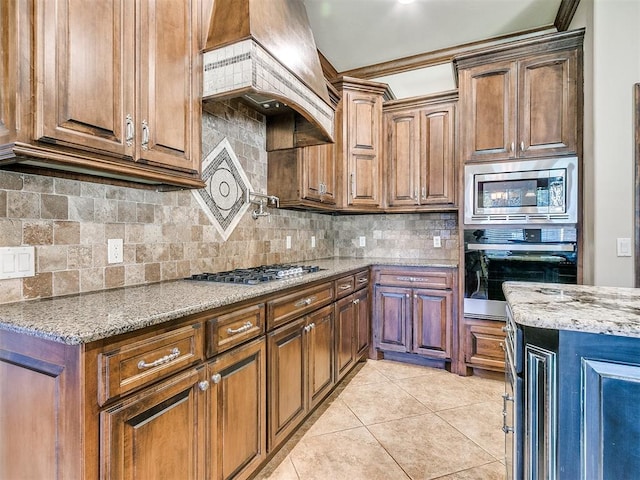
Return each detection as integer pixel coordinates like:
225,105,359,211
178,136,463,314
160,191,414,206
135,0,200,172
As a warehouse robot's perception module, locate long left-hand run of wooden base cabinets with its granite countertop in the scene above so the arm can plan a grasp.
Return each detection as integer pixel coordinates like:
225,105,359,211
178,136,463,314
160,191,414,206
0,258,457,480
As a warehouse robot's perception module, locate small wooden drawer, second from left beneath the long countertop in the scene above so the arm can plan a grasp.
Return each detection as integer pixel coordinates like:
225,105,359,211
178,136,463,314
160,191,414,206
207,303,265,357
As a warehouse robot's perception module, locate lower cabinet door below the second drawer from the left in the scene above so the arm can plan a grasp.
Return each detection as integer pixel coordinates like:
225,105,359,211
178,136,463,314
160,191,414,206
208,339,267,480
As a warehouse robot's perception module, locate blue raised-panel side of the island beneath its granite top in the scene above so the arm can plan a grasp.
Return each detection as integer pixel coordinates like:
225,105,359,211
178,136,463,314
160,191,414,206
557,330,640,480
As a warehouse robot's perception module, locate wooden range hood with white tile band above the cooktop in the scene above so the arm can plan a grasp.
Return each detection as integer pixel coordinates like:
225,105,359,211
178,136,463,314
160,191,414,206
202,0,335,150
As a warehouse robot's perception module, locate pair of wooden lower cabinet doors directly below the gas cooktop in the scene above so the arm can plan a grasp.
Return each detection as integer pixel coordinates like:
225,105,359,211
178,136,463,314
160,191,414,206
267,305,335,451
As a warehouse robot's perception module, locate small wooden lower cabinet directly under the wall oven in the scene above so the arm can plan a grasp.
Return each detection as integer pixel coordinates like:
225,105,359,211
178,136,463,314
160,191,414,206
463,318,505,372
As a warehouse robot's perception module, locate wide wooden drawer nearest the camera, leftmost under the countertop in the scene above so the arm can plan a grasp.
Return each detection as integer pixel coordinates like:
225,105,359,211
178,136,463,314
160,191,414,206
98,323,204,405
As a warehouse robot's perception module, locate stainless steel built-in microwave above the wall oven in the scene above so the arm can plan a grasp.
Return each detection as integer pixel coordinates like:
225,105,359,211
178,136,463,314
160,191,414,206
464,157,578,225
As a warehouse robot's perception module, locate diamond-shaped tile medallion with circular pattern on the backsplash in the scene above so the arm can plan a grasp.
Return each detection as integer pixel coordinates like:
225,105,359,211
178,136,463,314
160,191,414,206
193,138,252,240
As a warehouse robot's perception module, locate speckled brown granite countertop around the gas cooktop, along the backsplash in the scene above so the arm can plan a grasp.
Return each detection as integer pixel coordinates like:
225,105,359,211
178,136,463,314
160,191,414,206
0,258,458,345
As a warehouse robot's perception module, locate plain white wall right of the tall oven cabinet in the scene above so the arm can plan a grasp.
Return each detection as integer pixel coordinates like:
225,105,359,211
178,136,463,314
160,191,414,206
572,0,640,287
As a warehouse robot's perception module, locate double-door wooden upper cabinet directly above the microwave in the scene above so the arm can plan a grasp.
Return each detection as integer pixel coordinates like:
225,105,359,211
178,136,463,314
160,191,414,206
456,30,584,162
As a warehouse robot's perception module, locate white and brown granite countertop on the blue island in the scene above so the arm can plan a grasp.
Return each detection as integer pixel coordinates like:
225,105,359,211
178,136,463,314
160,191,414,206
502,282,640,337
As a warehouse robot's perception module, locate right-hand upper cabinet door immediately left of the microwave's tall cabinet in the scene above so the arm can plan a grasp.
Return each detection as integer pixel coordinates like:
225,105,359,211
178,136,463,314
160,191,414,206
420,105,456,205
